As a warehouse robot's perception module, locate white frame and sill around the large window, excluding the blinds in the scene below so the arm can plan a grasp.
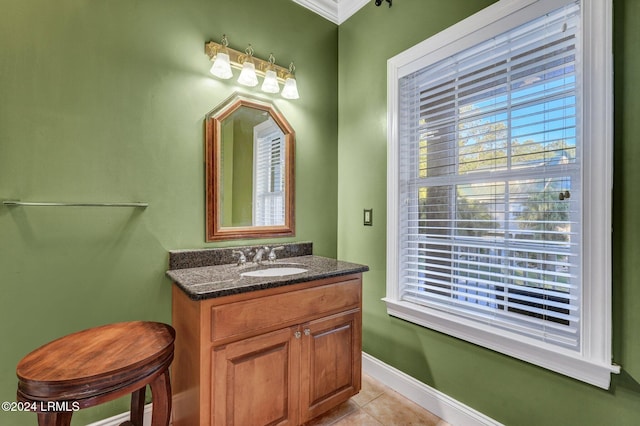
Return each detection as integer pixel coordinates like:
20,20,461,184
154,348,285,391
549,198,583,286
383,0,620,389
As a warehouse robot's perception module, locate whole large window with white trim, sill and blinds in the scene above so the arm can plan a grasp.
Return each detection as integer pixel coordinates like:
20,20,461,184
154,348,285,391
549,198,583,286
384,0,620,388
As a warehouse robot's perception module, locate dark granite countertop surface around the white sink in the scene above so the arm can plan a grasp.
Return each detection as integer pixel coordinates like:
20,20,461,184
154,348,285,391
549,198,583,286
167,248,369,300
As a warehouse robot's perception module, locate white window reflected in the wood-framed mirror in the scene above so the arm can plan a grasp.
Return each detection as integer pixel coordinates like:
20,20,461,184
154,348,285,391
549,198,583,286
253,119,285,226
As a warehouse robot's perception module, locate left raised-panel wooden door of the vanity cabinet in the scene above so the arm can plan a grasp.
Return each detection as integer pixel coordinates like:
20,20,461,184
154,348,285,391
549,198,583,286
211,327,300,426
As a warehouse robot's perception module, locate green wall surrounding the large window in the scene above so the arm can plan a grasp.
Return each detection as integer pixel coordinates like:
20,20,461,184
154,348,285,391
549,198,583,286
338,0,640,426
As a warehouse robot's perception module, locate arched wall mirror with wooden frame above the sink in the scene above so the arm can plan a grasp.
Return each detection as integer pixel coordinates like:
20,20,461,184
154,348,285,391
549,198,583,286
205,95,294,241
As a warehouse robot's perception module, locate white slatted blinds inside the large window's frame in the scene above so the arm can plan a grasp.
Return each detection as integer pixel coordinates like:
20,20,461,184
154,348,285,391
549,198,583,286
398,3,582,350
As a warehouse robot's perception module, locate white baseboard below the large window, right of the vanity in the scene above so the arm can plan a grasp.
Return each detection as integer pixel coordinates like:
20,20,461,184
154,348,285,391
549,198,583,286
362,352,503,426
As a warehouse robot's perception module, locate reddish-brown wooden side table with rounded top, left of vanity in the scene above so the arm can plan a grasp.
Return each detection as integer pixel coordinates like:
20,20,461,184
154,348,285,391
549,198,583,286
16,321,175,426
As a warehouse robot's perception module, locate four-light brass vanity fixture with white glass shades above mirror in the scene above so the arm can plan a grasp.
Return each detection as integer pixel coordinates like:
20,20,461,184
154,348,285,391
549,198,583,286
204,35,300,99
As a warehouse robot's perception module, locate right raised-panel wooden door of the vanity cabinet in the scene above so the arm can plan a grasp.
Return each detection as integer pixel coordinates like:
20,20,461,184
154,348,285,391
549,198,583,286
300,310,362,422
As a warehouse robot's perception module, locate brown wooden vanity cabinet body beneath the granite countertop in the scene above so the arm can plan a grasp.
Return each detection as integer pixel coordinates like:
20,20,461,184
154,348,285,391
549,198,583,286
171,273,362,426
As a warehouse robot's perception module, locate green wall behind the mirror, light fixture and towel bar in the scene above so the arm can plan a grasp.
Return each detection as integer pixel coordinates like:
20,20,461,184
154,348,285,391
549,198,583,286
0,0,338,426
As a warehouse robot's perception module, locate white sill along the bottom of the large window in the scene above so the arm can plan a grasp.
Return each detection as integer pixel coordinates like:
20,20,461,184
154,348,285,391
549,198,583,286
382,298,620,389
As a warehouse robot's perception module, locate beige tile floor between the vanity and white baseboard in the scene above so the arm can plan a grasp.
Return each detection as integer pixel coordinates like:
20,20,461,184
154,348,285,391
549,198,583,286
307,374,449,426
